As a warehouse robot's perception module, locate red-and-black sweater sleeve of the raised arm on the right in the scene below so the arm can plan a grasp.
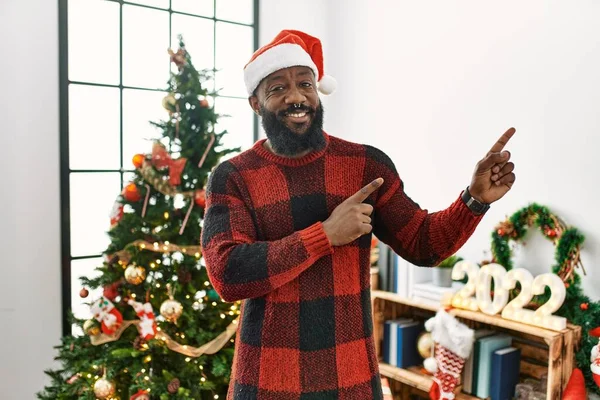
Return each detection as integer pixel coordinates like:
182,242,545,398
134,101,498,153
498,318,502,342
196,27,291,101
367,146,482,267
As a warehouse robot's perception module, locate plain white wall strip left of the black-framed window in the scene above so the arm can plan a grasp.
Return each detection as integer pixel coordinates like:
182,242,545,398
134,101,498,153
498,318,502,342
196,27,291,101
0,0,61,400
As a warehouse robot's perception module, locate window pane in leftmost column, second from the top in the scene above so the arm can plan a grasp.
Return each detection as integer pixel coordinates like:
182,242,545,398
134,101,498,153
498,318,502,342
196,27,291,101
69,85,120,169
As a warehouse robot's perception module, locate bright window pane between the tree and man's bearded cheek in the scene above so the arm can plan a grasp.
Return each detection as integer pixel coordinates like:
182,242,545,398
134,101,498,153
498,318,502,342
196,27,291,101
215,97,254,156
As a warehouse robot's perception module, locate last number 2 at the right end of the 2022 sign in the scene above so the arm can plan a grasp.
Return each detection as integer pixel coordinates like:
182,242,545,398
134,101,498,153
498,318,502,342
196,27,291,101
532,273,567,330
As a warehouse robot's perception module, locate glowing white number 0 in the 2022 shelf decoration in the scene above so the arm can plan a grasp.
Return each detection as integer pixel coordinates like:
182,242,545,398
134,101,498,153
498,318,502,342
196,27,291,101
477,264,508,315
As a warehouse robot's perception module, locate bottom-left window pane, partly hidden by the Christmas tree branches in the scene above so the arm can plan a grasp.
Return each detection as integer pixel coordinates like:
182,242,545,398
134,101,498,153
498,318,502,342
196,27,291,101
71,257,102,319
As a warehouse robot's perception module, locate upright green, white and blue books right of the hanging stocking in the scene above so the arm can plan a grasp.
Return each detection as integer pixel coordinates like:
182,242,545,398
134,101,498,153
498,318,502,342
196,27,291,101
461,329,521,400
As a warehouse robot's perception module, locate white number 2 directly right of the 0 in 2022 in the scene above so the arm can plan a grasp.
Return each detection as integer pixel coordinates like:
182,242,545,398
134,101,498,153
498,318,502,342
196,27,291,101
502,268,533,324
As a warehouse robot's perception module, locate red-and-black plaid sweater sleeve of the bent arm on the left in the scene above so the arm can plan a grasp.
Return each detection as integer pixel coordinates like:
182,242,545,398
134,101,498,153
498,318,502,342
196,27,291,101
201,161,333,302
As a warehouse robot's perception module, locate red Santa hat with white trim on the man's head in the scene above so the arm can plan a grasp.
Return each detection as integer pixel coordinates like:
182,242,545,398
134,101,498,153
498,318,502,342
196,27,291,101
244,30,337,96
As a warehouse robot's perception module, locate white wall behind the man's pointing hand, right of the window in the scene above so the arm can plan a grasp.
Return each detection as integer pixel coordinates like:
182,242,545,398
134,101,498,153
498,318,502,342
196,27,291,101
261,0,600,300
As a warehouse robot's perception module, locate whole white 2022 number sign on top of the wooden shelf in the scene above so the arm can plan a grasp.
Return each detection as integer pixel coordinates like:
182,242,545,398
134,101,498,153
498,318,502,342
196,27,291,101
452,261,567,330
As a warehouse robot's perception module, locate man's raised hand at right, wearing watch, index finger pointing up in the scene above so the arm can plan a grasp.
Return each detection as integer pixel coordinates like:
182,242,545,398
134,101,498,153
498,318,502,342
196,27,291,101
469,128,516,203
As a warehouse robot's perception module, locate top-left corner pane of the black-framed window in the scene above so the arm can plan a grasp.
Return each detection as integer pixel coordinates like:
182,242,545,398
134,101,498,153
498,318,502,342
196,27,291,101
68,0,119,85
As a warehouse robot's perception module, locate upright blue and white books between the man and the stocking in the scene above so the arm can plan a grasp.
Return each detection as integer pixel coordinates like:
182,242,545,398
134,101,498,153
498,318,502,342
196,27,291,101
382,318,424,368
